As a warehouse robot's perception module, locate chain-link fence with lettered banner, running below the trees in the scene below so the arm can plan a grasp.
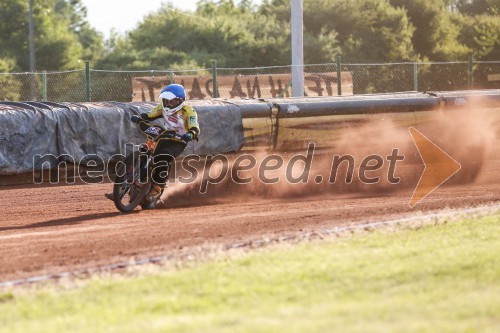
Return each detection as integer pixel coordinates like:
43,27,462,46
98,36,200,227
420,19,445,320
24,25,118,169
0,58,500,102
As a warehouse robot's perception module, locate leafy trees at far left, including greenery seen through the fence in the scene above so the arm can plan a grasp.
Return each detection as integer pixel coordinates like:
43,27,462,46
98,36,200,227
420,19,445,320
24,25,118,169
0,0,103,100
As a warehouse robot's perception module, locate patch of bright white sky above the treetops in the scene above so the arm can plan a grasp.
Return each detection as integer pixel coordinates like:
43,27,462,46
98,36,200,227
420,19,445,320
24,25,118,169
82,0,262,38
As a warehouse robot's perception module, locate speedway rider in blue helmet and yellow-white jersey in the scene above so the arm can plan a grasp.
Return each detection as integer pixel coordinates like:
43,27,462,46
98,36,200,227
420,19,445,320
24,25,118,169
106,84,200,208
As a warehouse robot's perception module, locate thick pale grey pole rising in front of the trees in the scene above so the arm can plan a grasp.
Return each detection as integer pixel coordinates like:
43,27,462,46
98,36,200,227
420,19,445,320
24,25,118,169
291,0,304,97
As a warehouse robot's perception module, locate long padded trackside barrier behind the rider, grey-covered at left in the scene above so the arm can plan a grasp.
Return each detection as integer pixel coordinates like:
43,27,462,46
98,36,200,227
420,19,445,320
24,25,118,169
0,90,500,185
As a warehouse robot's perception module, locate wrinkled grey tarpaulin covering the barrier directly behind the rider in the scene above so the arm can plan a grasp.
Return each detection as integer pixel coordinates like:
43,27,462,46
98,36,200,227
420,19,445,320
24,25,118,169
0,102,243,175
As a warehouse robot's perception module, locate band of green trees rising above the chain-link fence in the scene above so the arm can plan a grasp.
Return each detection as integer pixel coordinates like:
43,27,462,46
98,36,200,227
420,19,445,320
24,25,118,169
0,0,500,71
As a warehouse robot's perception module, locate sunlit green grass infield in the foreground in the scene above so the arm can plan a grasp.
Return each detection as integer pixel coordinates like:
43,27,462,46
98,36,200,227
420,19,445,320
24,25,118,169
0,215,500,333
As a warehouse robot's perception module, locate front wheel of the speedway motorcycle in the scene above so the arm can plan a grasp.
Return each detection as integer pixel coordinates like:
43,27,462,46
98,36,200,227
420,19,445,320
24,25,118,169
113,154,151,213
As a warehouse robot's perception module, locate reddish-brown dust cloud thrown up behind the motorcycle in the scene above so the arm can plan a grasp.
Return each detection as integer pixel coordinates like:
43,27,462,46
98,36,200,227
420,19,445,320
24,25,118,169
162,107,500,207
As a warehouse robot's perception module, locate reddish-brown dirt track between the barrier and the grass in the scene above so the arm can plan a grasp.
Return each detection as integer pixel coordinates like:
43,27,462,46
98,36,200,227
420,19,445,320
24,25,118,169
0,154,500,282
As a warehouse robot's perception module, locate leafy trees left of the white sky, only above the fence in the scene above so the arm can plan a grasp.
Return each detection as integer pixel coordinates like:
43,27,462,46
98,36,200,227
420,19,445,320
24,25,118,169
0,0,103,71
